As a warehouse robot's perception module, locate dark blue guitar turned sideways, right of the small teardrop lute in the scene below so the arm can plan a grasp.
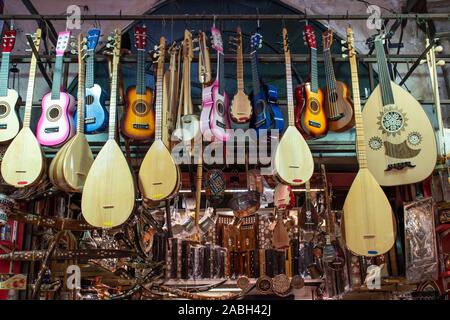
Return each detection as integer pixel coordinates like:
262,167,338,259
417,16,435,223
250,32,284,133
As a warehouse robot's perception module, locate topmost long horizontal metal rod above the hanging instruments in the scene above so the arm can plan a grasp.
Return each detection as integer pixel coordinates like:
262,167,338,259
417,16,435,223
0,12,450,21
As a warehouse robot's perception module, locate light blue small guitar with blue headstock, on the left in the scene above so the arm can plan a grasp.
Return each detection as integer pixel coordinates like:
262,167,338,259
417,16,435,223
75,28,108,133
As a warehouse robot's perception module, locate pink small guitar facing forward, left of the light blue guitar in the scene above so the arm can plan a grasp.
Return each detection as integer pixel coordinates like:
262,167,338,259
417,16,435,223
36,31,75,147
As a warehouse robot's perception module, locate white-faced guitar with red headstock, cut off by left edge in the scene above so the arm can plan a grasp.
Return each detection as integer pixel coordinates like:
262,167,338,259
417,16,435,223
0,30,20,142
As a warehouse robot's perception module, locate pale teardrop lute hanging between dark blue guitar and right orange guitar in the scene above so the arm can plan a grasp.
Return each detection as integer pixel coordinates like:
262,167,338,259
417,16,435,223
274,28,314,186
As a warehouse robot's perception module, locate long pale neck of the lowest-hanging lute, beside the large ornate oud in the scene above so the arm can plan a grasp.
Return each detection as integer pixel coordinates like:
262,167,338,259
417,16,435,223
349,42,367,168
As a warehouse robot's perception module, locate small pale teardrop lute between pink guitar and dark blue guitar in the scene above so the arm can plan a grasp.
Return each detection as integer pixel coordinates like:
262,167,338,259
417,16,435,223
230,27,252,129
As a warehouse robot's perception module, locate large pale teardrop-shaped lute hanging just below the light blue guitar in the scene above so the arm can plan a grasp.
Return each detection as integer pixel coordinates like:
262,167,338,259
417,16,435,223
81,29,135,228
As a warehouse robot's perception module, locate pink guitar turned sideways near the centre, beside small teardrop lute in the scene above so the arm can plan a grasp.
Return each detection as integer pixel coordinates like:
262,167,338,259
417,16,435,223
200,26,231,141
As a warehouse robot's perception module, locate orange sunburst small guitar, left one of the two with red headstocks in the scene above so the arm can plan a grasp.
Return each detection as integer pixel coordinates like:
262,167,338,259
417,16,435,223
121,27,155,140
